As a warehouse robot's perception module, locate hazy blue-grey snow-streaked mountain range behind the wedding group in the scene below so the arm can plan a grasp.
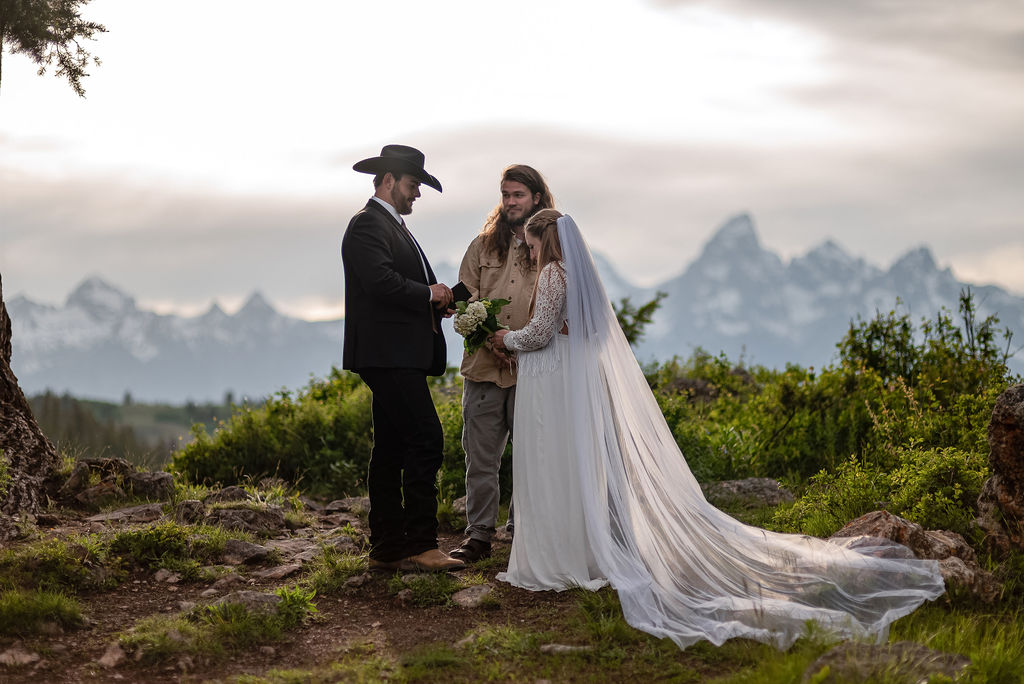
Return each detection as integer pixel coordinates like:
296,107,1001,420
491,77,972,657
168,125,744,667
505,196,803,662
7,214,1024,402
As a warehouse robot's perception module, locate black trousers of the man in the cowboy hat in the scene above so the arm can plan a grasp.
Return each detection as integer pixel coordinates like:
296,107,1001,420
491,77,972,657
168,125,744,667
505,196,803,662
358,369,444,561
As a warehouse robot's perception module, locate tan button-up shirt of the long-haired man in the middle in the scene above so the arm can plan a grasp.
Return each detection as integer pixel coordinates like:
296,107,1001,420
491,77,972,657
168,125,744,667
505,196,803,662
459,236,537,387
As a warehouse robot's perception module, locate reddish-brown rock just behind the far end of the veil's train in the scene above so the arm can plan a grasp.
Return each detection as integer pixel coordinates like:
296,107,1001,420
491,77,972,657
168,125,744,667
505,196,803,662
828,511,1002,603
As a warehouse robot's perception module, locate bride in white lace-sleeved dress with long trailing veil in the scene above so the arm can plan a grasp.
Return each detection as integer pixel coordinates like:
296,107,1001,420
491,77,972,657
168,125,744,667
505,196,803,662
495,209,944,648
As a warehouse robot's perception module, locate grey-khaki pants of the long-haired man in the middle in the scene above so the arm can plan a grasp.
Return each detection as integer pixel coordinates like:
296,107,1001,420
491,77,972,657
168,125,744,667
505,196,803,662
462,380,515,542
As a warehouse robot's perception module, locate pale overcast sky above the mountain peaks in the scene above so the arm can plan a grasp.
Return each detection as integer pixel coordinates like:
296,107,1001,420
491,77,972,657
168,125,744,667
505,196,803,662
0,0,1024,317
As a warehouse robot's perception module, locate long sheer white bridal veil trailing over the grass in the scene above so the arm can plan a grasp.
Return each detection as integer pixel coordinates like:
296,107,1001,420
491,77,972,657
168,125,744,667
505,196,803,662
558,216,944,648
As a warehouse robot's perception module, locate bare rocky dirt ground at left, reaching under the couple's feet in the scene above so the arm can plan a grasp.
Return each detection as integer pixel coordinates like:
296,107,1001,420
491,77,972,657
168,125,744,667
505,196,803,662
0,483,593,682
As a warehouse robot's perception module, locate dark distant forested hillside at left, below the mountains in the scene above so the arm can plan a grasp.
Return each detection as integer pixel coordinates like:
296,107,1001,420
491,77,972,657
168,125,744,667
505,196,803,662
29,392,233,469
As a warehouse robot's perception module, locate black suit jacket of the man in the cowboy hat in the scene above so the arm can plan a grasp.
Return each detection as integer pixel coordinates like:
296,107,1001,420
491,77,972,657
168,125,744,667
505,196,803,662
341,200,447,375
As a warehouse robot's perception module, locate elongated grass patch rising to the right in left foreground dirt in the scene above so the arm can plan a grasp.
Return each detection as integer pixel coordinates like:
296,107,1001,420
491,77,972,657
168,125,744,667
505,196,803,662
120,587,316,661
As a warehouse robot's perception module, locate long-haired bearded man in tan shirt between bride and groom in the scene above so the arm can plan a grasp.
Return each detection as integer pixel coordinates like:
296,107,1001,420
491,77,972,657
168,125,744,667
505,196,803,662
452,164,554,562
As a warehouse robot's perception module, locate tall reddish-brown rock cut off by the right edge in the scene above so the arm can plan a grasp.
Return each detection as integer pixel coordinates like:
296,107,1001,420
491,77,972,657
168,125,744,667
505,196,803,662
978,384,1024,556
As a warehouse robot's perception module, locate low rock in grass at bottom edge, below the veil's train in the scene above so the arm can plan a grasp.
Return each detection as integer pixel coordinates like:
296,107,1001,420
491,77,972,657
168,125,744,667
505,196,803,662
803,641,971,684
